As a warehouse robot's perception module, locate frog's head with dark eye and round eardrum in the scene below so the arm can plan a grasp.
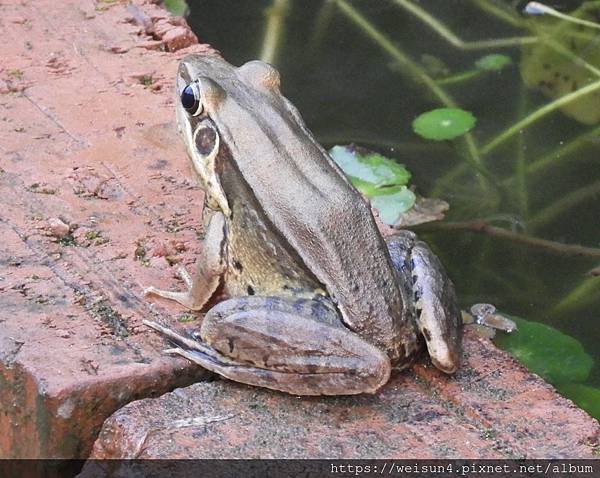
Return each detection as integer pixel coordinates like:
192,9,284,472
176,55,288,215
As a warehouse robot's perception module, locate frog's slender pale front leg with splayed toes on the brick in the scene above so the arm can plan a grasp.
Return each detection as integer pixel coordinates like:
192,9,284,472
144,212,225,310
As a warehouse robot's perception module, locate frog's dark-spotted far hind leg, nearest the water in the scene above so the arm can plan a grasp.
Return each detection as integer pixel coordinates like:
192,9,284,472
387,231,462,373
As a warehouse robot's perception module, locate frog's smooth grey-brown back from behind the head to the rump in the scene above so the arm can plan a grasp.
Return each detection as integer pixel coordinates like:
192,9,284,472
220,106,418,362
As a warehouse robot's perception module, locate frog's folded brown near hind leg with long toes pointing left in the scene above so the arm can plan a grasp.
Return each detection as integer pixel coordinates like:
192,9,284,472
146,296,391,395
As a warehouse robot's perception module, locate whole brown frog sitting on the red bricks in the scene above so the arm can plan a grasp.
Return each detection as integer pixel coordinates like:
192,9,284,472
145,55,462,395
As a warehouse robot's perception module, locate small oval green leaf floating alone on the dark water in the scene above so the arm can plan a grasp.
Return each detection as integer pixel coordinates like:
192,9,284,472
412,108,476,141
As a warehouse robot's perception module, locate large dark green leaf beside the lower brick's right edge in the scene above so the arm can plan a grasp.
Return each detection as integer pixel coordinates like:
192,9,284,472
495,316,594,384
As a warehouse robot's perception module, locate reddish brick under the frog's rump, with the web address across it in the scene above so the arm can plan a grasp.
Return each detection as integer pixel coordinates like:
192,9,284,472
92,333,599,459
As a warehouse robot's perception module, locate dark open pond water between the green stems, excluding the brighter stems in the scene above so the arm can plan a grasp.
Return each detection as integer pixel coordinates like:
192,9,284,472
188,0,600,414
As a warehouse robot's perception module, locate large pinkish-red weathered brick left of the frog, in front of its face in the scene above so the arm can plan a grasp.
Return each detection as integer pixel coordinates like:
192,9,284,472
0,0,213,458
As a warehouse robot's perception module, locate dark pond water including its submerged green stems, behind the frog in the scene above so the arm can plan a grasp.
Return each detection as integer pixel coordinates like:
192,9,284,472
188,0,600,416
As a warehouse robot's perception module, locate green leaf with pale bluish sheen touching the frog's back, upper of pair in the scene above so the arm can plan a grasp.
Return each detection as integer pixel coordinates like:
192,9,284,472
329,146,410,189
